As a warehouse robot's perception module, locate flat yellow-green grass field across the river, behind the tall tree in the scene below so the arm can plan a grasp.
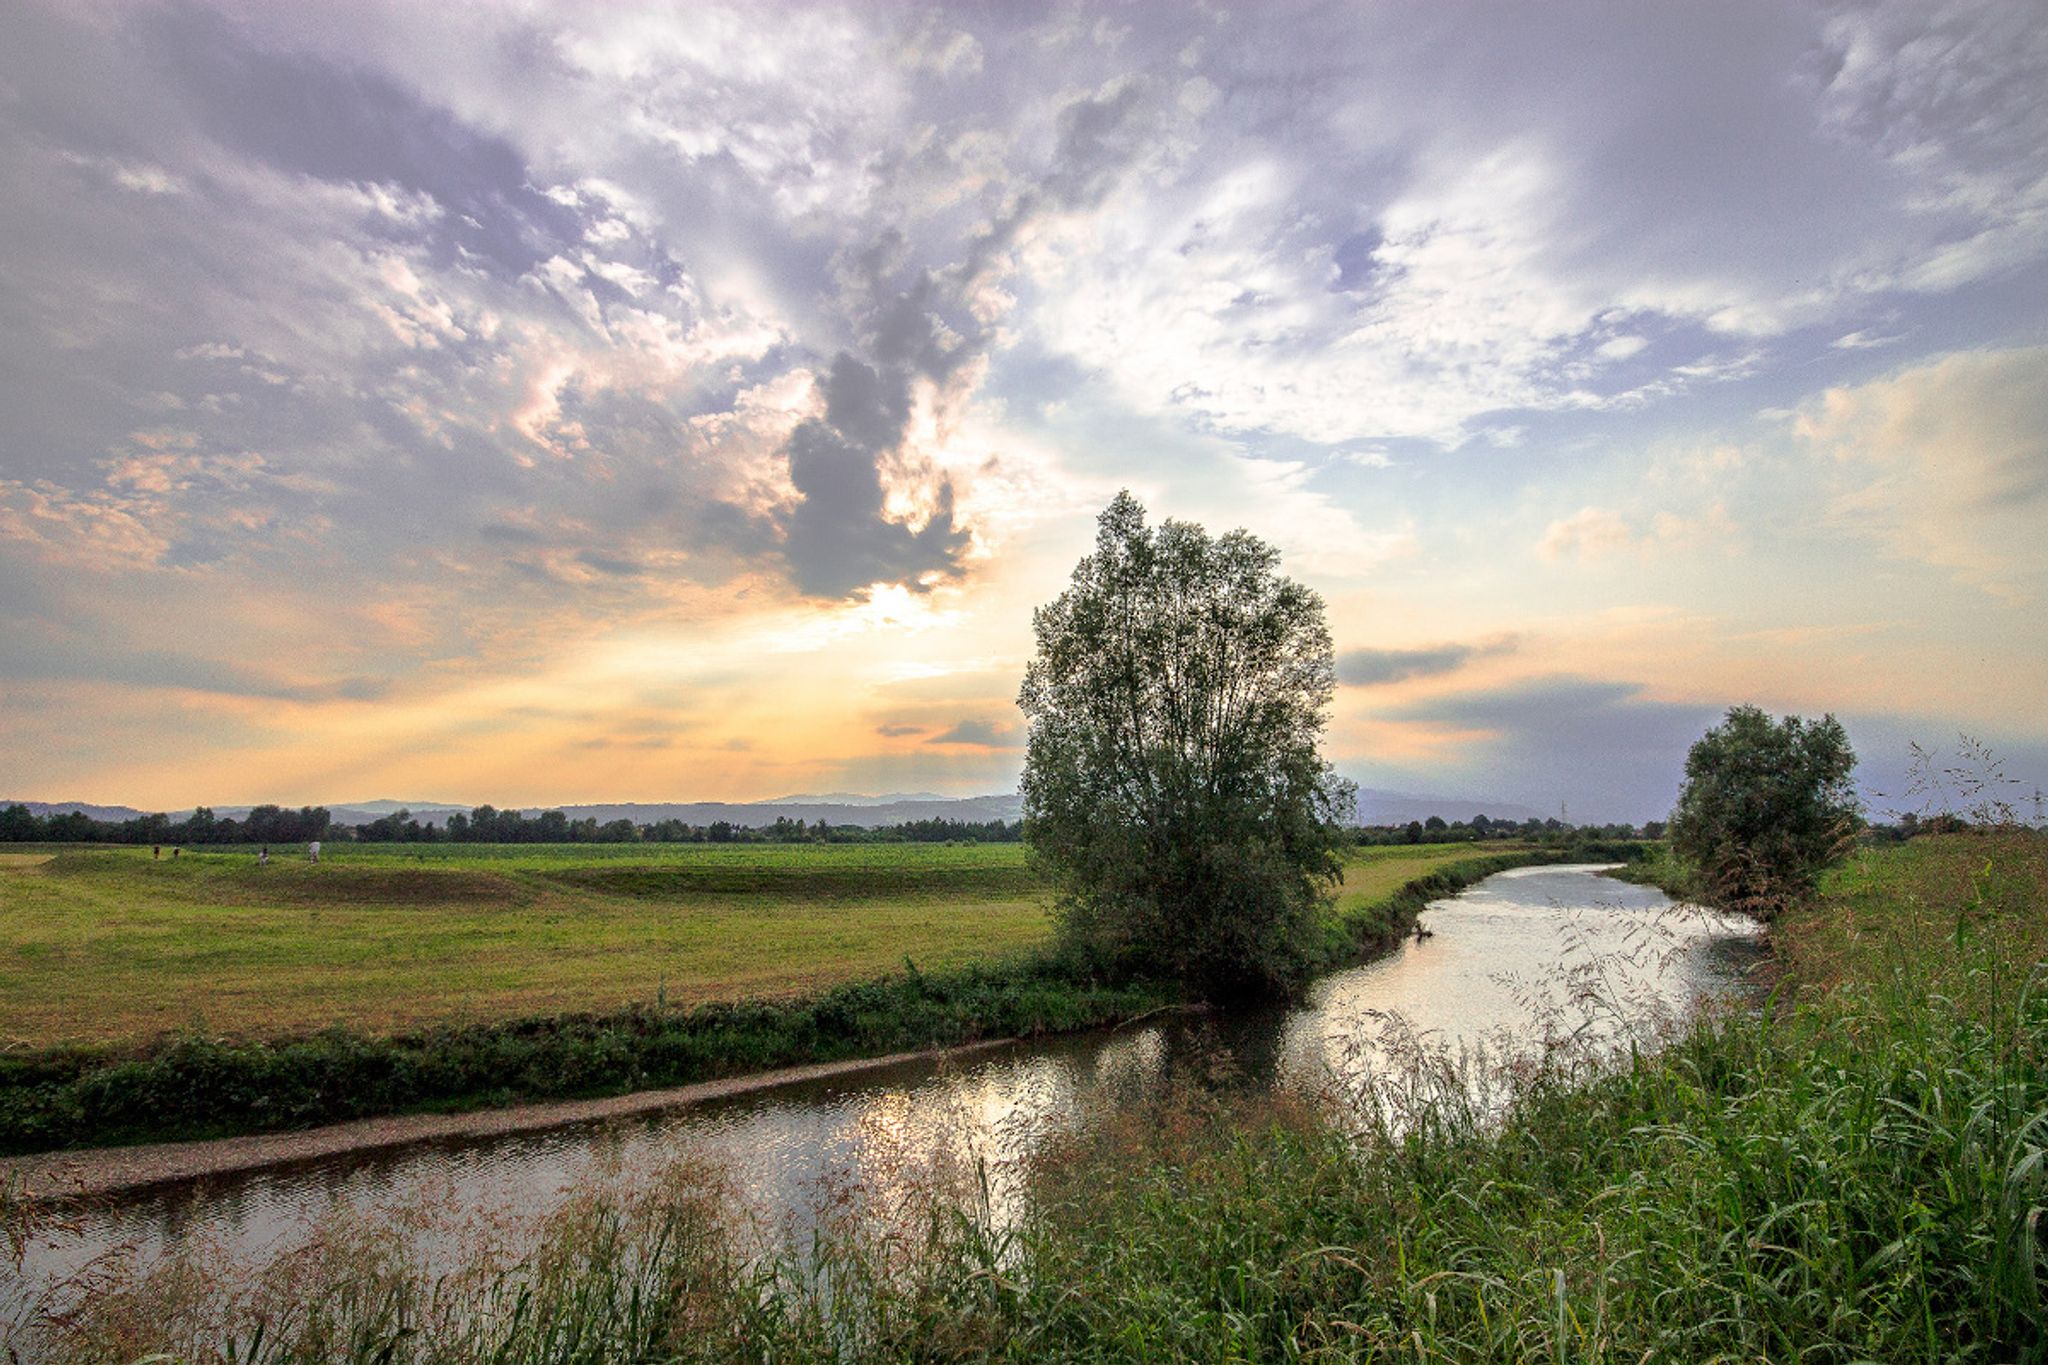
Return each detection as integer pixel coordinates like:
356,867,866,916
0,843,1501,1048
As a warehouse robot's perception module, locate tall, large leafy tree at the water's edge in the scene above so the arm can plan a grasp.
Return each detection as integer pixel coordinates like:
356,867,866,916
1018,491,1352,997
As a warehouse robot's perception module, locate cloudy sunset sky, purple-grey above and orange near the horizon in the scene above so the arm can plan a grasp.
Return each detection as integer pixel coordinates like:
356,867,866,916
0,0,2048,821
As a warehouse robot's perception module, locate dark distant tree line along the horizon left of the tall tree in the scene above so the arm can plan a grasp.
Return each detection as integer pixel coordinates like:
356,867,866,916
0,804,1024,845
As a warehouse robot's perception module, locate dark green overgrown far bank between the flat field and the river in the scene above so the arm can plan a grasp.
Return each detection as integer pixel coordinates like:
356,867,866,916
0,849,1561,1154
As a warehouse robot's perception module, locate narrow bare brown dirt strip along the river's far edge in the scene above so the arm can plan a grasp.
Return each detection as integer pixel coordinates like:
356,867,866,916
0,1038,1016,1199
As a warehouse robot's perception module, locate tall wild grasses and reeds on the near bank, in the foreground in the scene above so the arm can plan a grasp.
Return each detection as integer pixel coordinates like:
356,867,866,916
12,835,2048,1361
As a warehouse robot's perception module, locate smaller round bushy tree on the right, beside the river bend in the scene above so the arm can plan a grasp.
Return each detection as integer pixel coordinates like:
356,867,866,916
1669,706,1860,919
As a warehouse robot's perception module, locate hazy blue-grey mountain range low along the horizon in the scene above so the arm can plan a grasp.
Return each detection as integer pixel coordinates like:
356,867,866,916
0,788,1542,829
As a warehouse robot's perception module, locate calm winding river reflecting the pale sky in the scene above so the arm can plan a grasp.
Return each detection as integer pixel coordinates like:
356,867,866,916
0,866,1757,1347
